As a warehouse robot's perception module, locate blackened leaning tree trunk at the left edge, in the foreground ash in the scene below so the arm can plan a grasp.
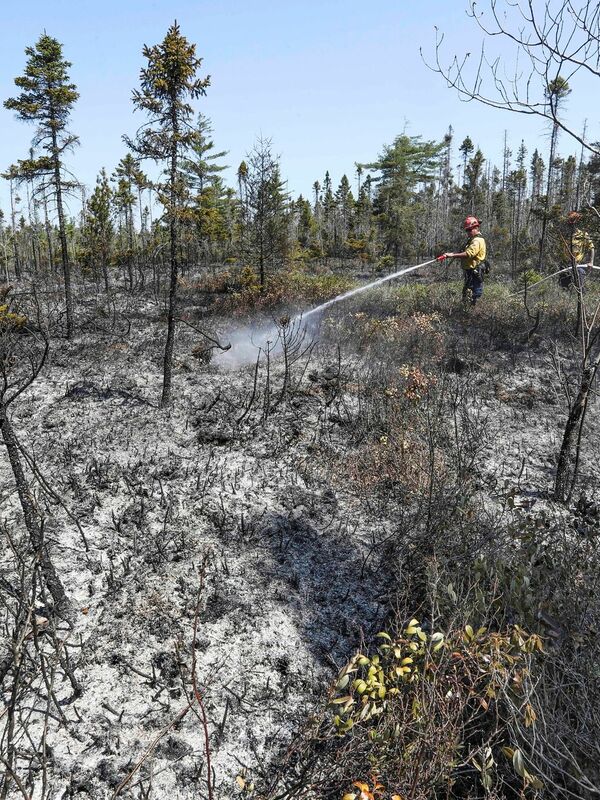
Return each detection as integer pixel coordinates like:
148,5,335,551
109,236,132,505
0,405,72,621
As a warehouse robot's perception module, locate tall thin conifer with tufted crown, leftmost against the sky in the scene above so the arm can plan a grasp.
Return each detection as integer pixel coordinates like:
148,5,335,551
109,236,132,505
4,33,79,338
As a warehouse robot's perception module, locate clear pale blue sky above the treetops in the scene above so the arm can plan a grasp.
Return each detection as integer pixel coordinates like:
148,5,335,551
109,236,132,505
0,0,600,212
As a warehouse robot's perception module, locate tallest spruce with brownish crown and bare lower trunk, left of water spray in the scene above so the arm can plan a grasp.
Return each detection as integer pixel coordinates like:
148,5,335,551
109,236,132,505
125,22,210,406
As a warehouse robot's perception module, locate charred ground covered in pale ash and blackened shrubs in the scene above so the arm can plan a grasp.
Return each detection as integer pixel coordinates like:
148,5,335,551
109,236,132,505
0,268,600,800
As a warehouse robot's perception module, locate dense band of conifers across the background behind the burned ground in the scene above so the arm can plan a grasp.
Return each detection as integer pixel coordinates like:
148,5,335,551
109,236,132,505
0,26,600,296
